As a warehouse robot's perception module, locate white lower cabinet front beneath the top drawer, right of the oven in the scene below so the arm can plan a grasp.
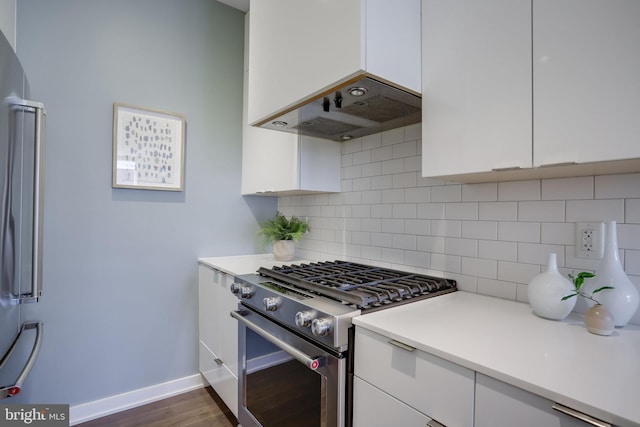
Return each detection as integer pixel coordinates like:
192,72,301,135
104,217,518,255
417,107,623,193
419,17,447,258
353,377,430,427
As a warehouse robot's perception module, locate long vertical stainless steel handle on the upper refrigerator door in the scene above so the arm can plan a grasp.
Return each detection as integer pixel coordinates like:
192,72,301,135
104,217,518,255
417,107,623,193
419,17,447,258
9,98,47,304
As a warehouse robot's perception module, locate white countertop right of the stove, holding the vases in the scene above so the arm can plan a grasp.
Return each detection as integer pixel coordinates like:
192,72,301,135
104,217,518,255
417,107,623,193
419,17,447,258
353,291,640,426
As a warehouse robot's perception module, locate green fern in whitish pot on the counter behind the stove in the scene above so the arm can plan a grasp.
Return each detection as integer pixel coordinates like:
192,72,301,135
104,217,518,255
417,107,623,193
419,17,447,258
258,212,311,261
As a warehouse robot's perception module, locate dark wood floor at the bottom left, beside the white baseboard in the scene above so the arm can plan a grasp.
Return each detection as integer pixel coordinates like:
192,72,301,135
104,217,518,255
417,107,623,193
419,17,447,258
77,387,238,427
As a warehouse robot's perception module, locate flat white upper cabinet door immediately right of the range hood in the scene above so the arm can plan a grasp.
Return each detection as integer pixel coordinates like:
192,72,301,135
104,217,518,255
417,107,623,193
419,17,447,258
422,0,532,176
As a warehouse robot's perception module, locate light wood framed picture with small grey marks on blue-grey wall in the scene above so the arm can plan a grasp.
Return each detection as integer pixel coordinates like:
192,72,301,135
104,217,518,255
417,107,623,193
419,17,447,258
113,103,185,191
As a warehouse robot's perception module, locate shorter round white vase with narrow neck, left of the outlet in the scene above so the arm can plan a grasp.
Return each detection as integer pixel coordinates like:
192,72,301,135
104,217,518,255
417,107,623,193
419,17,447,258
527,253,576,320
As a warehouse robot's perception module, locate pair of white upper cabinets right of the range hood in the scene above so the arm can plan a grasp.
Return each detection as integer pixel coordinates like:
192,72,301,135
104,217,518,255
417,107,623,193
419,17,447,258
422,0,640,181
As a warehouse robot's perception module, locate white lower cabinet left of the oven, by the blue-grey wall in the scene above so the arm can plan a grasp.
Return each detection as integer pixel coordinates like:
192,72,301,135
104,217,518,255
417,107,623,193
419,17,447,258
198,265,238,417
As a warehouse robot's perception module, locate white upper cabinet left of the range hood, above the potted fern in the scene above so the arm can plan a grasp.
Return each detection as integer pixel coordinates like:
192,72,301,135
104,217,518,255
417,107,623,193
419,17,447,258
241,11,342,196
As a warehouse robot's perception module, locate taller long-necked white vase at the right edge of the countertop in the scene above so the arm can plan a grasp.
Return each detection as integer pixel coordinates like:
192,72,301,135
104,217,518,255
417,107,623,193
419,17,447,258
583,221,640,327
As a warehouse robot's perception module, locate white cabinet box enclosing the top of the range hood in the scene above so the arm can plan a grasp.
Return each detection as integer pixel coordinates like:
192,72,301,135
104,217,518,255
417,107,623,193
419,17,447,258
248,0,421,125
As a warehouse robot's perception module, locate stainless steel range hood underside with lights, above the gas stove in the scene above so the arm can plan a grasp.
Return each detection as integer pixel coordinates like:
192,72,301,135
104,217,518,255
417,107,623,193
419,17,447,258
256,76,422,141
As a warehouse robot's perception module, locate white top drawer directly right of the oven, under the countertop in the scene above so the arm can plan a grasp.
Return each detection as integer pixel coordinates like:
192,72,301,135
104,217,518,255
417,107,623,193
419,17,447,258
354,327,475,427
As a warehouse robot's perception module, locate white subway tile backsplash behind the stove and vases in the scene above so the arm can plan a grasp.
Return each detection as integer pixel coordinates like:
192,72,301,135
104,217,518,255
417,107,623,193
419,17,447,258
278,124,640,323
